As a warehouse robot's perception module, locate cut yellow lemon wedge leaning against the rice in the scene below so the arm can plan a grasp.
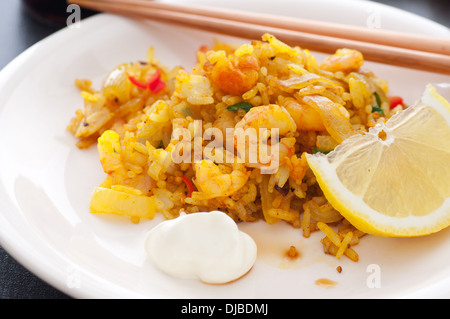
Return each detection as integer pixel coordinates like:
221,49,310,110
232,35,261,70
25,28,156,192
307,84,450,237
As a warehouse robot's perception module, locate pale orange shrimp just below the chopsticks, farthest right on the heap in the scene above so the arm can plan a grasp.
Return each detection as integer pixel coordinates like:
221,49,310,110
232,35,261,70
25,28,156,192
320,49,364,73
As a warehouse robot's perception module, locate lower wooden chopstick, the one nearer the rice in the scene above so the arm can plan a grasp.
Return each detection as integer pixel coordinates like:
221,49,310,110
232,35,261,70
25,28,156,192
69,0,450,74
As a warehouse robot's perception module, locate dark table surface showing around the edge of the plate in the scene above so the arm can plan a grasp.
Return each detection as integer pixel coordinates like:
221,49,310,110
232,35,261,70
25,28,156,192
0,0,450,299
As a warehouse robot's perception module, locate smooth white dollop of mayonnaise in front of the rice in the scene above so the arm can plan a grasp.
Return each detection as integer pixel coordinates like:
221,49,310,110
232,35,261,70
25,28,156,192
145,211,257,284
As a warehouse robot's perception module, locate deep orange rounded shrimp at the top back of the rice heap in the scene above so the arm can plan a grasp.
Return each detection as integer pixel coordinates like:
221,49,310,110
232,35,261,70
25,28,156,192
211,55,259,95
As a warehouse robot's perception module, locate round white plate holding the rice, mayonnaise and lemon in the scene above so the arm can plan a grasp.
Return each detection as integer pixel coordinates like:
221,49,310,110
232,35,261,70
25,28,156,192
0,0,450,298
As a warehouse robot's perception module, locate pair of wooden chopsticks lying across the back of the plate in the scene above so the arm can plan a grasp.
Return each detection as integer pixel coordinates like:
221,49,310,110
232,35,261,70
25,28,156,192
68,0,450,74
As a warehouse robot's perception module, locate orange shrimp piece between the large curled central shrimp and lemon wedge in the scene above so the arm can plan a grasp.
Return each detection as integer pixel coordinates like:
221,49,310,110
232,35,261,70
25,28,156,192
281,98,325,131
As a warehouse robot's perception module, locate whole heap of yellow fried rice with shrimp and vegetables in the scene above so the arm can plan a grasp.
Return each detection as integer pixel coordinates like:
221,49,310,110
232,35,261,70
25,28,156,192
68,34,404,261
